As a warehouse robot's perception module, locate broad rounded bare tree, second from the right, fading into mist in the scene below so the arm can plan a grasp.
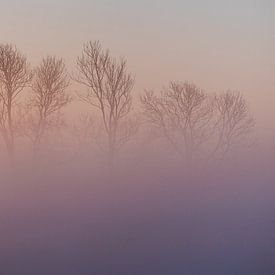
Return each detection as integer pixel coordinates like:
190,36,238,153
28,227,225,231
141,82,213,166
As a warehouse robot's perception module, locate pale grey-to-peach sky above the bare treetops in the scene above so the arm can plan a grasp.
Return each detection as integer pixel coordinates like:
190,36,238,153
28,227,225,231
0,0,275,136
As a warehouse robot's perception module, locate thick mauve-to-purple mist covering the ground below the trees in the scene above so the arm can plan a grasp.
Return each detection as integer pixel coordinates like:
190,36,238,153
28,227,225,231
0,144,275,275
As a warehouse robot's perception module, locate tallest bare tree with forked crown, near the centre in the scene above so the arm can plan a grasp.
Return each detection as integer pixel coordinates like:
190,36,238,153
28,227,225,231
76,41,134,167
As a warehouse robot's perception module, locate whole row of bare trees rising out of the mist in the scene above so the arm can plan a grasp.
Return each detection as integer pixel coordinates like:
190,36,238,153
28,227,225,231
0,41,254,167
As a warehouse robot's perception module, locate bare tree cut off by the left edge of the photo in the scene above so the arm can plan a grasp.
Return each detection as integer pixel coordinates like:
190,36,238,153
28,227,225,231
0,44,32,159
